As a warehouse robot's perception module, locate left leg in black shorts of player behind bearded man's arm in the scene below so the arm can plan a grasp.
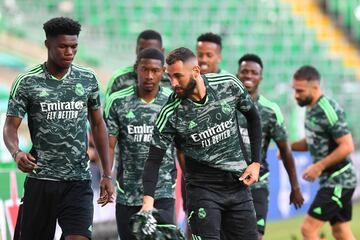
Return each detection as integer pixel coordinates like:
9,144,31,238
116,203,141,240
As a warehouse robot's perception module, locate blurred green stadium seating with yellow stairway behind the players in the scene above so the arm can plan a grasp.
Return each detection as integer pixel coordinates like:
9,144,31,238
0,0,360,144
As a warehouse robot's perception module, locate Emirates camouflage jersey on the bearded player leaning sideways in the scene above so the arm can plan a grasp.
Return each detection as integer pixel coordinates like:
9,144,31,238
152,73,254,175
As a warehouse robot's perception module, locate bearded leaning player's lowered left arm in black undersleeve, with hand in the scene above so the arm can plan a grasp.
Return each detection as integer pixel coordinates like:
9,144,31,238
140,145,166,211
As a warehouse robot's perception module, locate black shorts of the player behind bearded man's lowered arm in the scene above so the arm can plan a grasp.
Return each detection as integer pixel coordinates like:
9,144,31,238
116,198,175,240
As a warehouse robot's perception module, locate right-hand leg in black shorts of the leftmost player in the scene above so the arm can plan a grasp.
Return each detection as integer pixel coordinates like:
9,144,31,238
58,180,94,240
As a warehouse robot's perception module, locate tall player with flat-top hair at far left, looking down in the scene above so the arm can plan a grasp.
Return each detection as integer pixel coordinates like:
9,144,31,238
3,17,113,240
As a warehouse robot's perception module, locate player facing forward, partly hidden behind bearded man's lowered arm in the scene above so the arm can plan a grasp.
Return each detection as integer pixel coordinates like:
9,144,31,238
105,48,176,240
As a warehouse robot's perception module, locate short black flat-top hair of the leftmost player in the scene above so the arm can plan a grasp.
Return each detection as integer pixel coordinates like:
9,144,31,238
43,17,81,38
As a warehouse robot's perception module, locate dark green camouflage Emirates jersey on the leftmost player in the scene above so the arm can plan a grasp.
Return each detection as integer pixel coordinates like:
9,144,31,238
7,64,100,180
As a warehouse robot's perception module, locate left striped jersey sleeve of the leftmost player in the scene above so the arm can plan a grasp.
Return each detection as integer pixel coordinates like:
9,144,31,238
7,75,30,118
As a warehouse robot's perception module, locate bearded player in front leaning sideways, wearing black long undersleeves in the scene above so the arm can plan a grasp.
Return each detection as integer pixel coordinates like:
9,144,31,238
141,48,261,240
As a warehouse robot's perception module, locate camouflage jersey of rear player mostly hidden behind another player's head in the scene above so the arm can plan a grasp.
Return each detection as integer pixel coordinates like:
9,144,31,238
106,66,171,98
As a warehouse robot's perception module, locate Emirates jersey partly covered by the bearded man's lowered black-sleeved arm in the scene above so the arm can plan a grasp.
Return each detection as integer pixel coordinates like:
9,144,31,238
105,85,175,206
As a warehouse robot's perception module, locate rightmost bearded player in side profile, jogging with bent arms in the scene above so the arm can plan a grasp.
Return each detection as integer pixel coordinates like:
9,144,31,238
291,66,356,240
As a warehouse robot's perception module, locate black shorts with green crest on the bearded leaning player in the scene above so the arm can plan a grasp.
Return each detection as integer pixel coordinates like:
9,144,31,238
186,181,258,240
